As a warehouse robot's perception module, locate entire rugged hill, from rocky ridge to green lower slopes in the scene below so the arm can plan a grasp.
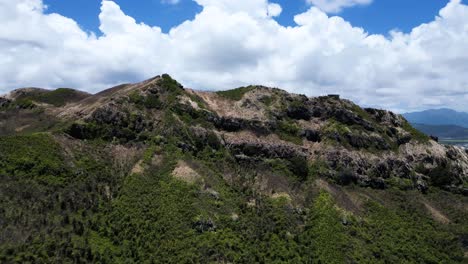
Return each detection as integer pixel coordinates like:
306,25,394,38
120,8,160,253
0,75,468,263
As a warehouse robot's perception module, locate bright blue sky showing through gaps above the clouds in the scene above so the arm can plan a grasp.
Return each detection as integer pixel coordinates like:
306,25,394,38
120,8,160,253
44,0,460,35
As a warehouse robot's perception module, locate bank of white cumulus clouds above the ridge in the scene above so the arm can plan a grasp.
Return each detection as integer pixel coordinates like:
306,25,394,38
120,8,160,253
0,0,468,110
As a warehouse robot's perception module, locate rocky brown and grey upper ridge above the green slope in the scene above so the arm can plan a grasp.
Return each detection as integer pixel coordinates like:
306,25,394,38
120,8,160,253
0,76,468,193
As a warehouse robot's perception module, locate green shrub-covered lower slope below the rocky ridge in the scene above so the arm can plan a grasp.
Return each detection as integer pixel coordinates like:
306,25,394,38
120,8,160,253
0,134,467,263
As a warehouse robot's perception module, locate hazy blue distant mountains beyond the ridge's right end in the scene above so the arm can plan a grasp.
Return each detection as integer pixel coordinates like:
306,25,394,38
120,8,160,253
403,108,468,139
